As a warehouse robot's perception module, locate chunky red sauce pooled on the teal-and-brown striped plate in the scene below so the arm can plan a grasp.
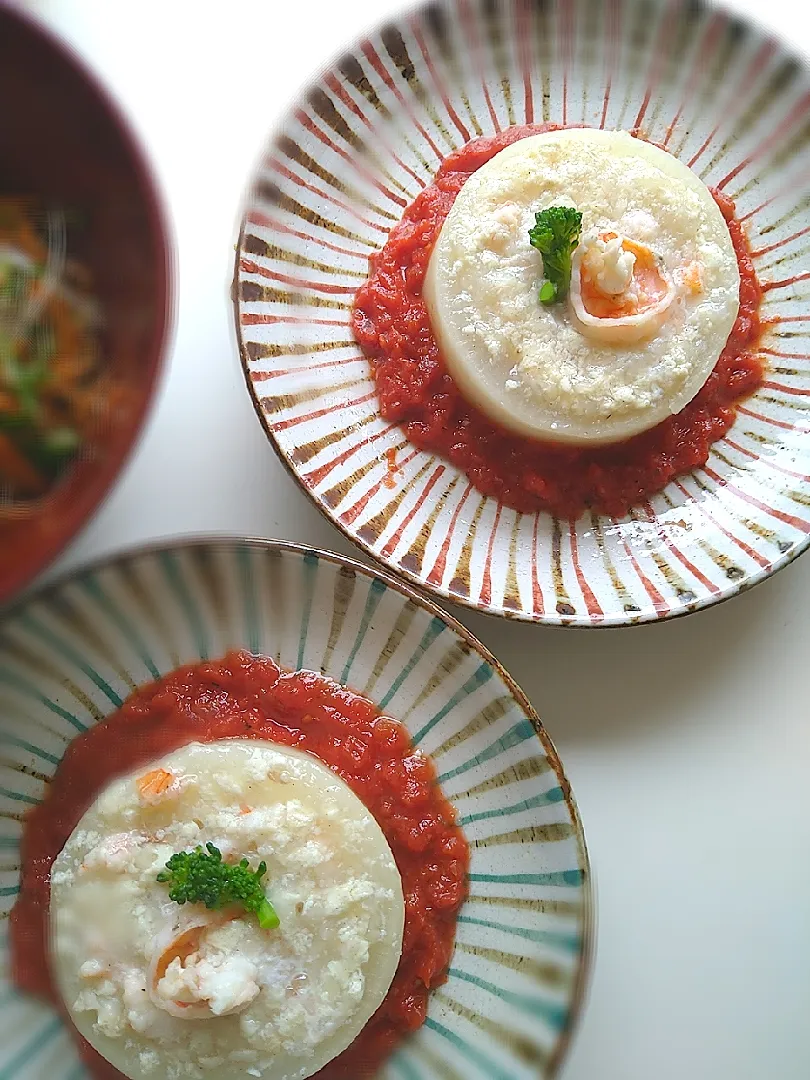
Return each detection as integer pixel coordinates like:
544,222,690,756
11,652,469,1080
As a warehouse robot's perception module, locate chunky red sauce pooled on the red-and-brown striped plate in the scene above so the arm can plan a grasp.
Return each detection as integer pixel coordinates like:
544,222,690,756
352,124,764,518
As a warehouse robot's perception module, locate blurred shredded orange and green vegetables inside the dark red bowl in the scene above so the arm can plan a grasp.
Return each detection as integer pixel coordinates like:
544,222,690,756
0,198,99,507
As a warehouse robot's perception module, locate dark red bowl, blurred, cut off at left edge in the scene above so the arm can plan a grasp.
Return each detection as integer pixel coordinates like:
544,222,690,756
0,3,172,604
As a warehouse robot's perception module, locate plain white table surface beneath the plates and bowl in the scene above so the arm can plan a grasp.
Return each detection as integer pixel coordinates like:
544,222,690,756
22,0,810,1080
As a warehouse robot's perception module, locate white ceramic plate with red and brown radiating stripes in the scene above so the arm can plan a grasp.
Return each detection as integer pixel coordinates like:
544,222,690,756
234,0,810,626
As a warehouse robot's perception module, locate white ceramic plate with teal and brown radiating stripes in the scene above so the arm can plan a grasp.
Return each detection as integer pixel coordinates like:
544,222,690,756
0,540,592,1080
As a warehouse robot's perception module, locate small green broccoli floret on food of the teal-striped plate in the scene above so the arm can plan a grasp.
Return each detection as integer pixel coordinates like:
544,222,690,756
158,843,279,930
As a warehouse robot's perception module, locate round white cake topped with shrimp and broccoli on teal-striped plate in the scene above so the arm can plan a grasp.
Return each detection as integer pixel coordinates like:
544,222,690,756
51,739,405,1080
